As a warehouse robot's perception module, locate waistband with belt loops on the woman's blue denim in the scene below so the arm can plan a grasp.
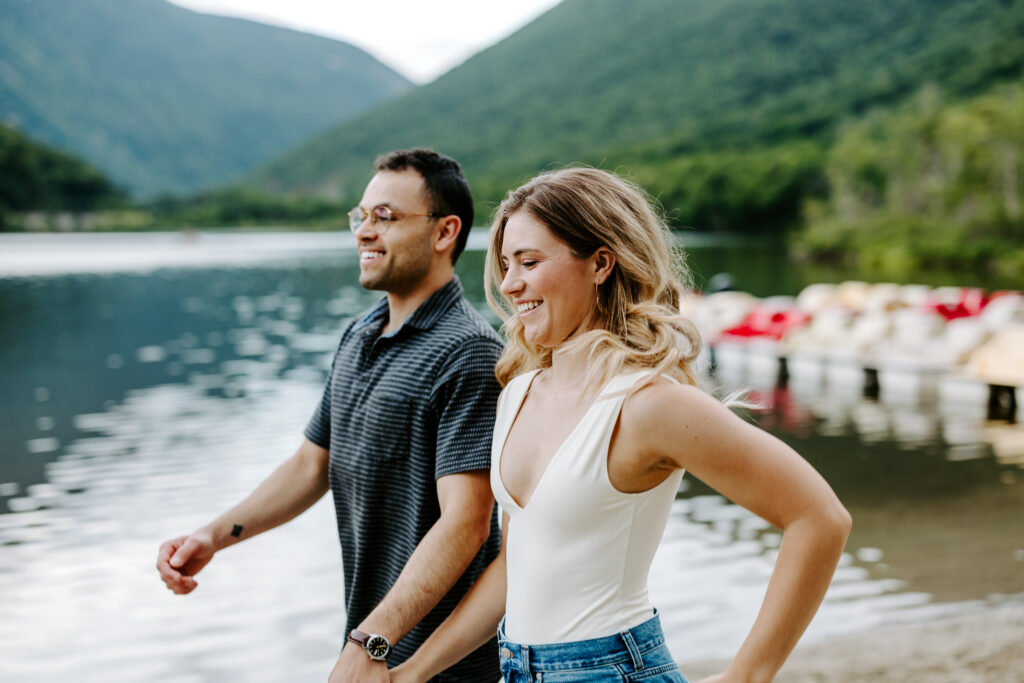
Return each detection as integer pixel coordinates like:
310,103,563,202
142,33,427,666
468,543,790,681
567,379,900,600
498,609,665,674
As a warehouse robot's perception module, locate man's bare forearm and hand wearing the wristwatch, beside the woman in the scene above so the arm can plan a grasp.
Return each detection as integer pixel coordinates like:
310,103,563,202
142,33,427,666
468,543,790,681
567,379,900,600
330,470,495,683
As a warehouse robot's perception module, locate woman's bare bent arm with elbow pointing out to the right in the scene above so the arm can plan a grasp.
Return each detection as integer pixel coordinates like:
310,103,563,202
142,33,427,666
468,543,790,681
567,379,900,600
617,382,851,682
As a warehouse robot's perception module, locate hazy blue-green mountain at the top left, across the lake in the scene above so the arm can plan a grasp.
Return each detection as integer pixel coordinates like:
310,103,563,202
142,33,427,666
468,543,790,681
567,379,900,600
0,0,412,196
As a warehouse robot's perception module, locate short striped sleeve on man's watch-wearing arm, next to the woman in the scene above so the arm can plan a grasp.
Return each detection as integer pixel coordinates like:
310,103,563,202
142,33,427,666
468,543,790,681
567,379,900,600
433,337,502,479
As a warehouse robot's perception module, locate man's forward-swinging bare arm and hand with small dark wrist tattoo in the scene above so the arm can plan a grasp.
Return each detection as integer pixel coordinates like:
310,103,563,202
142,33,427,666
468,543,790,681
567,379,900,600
157,439,329,594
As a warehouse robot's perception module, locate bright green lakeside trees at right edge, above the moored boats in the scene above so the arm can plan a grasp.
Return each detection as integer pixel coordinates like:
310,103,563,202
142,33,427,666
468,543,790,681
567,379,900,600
796,82,1024,275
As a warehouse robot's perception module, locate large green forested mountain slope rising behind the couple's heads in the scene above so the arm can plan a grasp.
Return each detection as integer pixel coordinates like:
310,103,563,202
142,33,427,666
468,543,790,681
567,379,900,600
252,0,1024,229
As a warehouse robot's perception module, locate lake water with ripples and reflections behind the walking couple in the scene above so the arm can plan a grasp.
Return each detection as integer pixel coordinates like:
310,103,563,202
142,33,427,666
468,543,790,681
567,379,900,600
0,232,1024,683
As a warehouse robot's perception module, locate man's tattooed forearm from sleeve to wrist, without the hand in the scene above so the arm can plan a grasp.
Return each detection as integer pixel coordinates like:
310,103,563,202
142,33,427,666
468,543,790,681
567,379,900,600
200,441,329,550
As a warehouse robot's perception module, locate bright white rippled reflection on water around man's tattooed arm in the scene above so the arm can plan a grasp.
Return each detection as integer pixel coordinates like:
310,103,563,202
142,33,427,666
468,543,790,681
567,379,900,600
0,375,343,682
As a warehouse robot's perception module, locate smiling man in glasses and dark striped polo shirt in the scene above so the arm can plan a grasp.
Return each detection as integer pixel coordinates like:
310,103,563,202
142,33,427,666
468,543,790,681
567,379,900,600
157,150,502,683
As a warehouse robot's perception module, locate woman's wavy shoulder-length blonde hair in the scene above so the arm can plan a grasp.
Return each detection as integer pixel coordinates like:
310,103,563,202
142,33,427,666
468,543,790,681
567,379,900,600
484,167,700,395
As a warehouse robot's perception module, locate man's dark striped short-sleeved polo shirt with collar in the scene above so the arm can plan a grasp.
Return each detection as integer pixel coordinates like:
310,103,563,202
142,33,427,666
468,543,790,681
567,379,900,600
305,278,502,683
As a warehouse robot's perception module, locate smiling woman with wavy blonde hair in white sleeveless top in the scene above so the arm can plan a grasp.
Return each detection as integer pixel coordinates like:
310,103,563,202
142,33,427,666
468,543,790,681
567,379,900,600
391,168,850,683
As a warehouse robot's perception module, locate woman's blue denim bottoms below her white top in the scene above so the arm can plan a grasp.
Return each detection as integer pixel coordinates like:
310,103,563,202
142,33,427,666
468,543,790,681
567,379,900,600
498,611,686,683
